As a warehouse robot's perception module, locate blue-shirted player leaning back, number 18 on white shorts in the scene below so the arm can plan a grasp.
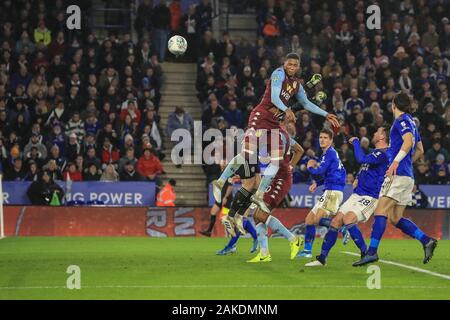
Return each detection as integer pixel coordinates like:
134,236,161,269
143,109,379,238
305,127,389,267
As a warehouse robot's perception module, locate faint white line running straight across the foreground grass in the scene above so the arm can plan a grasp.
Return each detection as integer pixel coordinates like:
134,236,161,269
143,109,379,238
0,285,450,290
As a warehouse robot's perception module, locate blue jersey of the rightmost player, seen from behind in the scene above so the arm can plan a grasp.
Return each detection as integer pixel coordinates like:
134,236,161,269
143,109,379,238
388,113,421,179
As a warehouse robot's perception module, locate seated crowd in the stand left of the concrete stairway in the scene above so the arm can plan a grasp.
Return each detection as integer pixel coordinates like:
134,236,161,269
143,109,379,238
0,0,176,188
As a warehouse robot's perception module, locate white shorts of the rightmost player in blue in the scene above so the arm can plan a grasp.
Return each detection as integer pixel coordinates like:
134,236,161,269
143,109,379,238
380,176,414,206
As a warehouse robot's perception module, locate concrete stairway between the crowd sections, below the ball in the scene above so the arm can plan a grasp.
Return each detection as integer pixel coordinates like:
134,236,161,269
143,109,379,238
159,62,207,206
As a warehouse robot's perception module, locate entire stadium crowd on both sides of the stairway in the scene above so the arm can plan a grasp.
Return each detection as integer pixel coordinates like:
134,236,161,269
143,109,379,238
0,0,450,192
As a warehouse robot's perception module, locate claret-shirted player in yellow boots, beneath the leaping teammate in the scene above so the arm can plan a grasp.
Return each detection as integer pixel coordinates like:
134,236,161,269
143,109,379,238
247,121,304,262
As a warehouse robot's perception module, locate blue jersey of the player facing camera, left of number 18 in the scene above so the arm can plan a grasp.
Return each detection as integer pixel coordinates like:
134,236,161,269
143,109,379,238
308,147,347,191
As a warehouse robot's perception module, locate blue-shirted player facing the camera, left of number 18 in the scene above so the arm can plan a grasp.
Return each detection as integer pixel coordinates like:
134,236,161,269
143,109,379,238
298,129,347,258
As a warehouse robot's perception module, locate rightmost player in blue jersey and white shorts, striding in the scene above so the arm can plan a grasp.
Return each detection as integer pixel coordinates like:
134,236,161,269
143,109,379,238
353,93,437,267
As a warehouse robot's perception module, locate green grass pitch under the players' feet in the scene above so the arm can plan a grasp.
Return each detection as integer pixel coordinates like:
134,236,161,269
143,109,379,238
0,237,450,300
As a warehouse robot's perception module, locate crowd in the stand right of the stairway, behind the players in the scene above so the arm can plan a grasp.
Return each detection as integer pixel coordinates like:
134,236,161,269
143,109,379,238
197,0,450,184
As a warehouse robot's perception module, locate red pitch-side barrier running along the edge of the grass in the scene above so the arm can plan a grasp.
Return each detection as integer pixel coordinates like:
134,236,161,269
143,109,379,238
4,206,450,239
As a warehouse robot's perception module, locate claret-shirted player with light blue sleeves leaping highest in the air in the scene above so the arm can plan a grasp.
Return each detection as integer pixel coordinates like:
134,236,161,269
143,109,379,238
213,53,339,232
